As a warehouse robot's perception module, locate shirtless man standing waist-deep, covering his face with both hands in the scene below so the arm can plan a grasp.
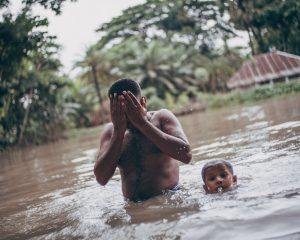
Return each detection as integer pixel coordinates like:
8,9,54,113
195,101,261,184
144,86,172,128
94,79,192,201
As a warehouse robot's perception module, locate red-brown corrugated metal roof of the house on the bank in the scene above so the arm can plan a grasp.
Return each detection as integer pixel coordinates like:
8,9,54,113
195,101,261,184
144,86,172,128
227,51,300,88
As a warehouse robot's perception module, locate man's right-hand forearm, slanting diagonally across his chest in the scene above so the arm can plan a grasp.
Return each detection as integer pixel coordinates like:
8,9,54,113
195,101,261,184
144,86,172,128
139,121,191,163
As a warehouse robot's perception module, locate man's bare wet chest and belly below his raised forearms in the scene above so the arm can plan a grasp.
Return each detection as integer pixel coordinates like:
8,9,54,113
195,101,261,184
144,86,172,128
118,112,179,201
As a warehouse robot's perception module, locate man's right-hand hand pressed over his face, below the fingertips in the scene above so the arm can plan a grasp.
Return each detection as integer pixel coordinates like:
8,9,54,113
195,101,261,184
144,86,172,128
123,91,147,129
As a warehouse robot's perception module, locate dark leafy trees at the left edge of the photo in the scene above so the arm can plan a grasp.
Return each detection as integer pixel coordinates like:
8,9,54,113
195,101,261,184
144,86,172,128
0,1,77,149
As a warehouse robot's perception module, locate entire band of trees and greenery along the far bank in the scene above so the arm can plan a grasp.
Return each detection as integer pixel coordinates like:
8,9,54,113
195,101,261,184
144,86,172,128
0,0,300,149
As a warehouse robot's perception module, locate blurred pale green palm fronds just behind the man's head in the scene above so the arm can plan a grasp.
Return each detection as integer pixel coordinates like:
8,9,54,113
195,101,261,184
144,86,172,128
109,37,205,98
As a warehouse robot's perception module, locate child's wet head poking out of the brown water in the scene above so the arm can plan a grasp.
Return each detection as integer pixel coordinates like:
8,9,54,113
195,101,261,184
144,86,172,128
201,160,237,193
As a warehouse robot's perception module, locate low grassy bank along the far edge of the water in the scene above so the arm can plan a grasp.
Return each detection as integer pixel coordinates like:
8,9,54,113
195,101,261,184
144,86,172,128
1,80,300,153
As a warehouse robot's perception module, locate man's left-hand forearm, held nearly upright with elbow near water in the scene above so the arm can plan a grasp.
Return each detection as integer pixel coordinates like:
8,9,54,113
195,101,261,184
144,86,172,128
94,132,124,185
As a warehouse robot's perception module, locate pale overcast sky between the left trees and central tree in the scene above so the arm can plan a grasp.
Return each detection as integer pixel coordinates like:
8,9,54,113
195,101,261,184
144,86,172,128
10,0,145,73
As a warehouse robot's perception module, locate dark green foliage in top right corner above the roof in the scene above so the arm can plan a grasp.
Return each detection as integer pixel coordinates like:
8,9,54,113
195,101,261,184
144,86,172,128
220,0,300,55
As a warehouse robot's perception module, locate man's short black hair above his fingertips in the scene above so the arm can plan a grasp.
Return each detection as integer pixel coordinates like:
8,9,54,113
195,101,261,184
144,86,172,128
108,78,141,97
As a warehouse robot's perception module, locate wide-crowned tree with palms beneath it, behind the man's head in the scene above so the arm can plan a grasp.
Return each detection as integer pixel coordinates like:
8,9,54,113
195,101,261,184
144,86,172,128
86,0,242,107
